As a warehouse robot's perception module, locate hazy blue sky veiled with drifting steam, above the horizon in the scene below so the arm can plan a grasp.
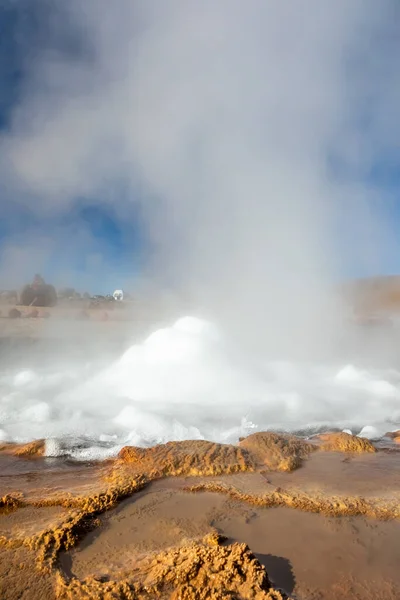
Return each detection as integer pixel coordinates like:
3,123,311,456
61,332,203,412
0,0,400,291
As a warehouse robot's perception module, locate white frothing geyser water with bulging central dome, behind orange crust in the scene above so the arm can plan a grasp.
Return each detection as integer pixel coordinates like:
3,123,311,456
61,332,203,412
0,317,400,460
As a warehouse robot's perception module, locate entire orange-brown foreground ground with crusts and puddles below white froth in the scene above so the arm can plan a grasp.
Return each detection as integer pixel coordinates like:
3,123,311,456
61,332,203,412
0,433,400,600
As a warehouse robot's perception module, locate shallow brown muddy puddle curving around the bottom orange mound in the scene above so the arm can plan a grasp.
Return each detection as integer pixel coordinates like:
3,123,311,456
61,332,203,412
61,475,400,600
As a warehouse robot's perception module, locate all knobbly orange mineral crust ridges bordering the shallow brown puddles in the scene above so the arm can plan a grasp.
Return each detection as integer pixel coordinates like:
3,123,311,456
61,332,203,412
0,433,400,600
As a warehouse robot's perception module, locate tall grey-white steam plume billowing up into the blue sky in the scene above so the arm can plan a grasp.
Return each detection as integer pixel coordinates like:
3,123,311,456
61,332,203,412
0,0,400,347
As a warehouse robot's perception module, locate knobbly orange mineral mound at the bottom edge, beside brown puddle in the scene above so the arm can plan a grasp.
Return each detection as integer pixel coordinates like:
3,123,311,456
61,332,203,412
57,535,287,600
